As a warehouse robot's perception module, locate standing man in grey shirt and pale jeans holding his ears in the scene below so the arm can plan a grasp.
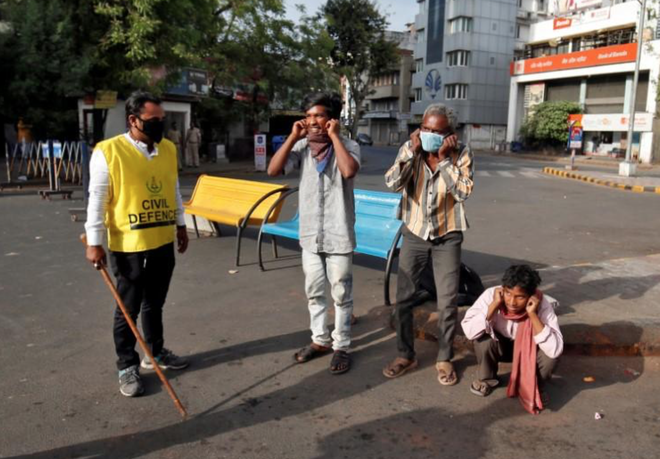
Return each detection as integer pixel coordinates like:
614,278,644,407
268,93,360,374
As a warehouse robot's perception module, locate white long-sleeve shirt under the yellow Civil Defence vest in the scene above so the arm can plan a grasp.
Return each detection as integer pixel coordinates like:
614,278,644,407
85,133,186,245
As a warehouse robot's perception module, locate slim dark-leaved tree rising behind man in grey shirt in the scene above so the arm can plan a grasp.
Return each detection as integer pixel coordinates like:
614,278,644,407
320,0,399,136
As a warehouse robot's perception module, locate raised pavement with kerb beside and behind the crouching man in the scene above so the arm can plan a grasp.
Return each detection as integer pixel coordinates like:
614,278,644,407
408,255,660,356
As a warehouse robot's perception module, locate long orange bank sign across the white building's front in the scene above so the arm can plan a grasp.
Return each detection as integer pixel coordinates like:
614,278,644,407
511,43,637,76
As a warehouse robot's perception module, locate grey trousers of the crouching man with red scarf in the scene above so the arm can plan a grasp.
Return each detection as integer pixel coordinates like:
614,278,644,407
474,334,559,387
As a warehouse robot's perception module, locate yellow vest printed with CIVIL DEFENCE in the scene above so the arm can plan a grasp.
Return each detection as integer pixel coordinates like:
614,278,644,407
97,134,177,252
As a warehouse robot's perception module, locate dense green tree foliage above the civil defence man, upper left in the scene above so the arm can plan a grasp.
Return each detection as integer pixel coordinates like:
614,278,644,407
0,0,337,138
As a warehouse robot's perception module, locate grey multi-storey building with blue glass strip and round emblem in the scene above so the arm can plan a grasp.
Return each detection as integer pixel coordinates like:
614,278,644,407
412,0,547,148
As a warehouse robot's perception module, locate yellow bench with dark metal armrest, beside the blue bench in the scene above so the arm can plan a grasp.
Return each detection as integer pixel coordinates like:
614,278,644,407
183,174,288,266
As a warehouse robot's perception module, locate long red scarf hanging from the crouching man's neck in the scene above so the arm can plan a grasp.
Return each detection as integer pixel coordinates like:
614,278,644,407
500,290,543,414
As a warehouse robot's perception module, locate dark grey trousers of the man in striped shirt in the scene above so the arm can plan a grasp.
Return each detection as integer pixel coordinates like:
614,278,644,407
395,226,463,362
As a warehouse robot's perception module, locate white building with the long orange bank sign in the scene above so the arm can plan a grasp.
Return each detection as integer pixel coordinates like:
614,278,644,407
507,0,660,162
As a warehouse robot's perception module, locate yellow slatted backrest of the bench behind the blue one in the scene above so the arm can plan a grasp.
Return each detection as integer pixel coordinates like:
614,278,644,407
186,174,287,222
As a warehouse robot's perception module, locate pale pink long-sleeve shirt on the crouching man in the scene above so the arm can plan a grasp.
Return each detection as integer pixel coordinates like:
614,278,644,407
461,287,564,359
